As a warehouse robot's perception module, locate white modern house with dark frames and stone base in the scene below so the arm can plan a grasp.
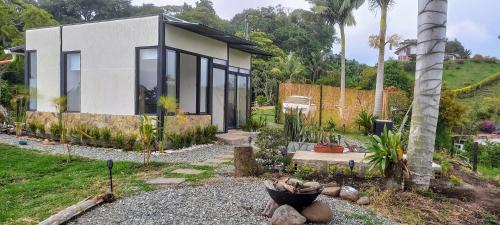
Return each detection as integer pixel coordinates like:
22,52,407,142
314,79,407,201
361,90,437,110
25,14,269,132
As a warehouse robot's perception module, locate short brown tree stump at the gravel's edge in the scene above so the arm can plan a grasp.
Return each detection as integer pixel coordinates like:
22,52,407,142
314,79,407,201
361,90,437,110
234,146,259,177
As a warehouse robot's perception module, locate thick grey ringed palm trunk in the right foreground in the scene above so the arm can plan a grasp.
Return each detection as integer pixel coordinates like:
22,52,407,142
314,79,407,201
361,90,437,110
408,0,448,190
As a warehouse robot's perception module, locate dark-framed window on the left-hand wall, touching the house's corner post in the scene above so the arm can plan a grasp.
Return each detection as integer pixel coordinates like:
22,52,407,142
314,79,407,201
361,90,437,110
137,48,158,114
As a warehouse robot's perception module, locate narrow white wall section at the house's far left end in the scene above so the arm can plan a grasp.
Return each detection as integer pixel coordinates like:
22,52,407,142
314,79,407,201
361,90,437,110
26,27,60,112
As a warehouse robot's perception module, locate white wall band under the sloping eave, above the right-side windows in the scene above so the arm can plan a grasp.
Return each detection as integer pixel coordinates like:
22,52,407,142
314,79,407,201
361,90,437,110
165,24,227,59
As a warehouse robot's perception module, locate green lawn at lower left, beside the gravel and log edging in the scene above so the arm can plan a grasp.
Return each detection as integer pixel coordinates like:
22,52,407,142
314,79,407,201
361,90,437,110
0,145,214,224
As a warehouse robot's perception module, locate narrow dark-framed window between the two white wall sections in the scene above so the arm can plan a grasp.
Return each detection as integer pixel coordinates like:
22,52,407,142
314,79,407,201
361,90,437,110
65,52,81,112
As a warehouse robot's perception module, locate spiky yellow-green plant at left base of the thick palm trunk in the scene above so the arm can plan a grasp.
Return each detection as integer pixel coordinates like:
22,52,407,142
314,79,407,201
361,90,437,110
365,127,409,188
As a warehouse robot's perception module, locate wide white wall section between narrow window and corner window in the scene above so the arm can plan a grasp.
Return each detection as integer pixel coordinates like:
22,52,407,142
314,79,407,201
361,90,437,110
62,16,158,115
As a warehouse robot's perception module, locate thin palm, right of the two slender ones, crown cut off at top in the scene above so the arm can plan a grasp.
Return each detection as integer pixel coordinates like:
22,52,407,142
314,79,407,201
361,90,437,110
370,0,395,117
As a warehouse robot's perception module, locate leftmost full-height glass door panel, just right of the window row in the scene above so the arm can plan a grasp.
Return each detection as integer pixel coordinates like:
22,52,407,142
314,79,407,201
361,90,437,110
212,67,226,132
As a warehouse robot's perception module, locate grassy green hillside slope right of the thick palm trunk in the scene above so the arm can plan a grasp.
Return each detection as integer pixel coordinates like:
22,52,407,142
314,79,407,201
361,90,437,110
443,61,500,89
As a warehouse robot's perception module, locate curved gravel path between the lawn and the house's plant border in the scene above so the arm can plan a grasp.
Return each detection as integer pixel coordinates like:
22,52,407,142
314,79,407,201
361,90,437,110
0,134,232,163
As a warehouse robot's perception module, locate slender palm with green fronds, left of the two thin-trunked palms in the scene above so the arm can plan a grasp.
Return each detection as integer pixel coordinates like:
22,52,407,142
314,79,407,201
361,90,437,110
309,0,365,123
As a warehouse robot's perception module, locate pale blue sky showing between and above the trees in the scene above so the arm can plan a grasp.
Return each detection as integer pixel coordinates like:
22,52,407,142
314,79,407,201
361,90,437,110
132,0,500,65
